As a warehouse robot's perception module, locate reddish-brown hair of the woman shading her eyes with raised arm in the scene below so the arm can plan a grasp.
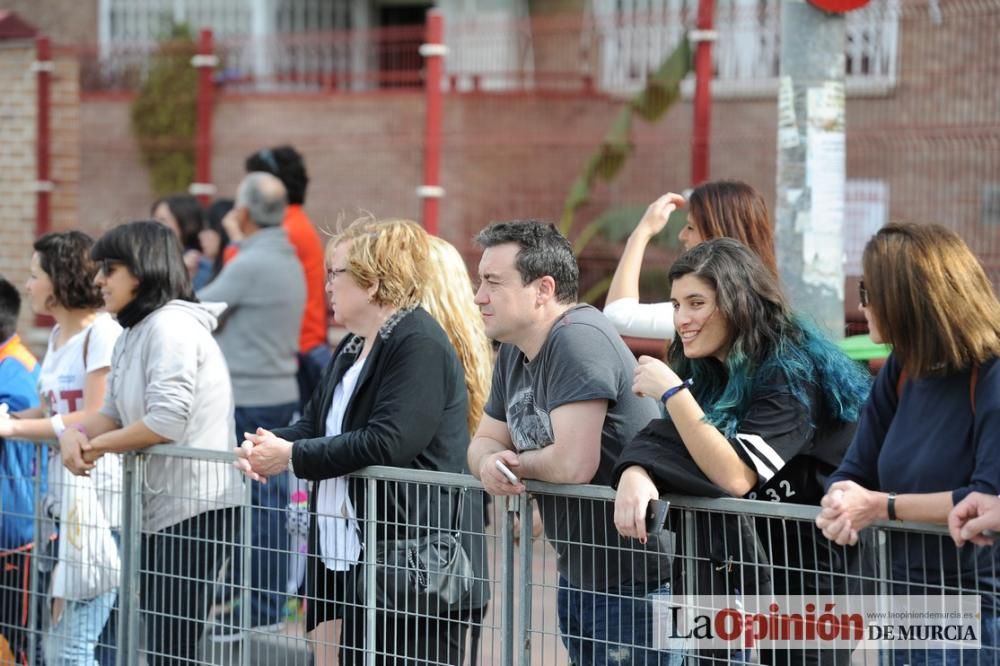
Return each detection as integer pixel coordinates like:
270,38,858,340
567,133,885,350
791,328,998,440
688,180,778,276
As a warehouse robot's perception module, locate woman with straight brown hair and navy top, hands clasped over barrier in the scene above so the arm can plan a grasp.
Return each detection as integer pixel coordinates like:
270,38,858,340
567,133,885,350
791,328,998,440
816,224,1000,664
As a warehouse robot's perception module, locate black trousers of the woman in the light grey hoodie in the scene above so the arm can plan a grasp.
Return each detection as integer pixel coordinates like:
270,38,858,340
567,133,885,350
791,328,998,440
139,508,238,666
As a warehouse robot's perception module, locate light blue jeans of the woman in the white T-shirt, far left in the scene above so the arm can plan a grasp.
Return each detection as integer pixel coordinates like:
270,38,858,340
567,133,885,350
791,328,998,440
44,589,118,666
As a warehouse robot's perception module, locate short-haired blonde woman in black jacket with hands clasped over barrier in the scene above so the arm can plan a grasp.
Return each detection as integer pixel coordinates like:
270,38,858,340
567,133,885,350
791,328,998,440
239,215,482,664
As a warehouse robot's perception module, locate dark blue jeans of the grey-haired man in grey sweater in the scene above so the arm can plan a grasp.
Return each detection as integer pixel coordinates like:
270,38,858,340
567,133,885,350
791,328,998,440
234,402,299,627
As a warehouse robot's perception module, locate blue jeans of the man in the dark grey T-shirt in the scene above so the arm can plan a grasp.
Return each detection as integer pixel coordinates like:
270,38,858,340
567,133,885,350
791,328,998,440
556,576,684,666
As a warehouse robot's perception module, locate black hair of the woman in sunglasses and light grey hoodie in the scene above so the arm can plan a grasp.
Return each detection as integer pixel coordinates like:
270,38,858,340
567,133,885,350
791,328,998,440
90,220,197,328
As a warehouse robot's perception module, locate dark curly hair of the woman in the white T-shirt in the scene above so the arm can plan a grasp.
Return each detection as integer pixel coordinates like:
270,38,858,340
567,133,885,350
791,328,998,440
34,231,104,310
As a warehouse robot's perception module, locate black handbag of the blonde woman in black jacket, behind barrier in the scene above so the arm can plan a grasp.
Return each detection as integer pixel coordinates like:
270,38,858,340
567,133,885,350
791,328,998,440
357,489,474,617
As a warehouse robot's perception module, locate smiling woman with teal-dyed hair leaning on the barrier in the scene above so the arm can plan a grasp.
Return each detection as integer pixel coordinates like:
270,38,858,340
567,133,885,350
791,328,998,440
614,238,870,663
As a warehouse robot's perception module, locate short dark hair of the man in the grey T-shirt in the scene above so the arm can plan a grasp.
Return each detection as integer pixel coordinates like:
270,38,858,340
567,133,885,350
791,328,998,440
476,220,580,303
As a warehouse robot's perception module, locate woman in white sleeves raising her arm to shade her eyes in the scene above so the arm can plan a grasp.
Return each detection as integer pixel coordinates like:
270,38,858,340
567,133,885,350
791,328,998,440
604,180,778,340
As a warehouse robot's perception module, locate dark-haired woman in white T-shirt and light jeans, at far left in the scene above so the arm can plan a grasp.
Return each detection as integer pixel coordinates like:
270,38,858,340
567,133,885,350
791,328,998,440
0,231,122,666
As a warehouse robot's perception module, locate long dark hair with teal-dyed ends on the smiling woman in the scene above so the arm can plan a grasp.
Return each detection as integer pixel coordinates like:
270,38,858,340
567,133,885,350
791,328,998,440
669,238,870,437
